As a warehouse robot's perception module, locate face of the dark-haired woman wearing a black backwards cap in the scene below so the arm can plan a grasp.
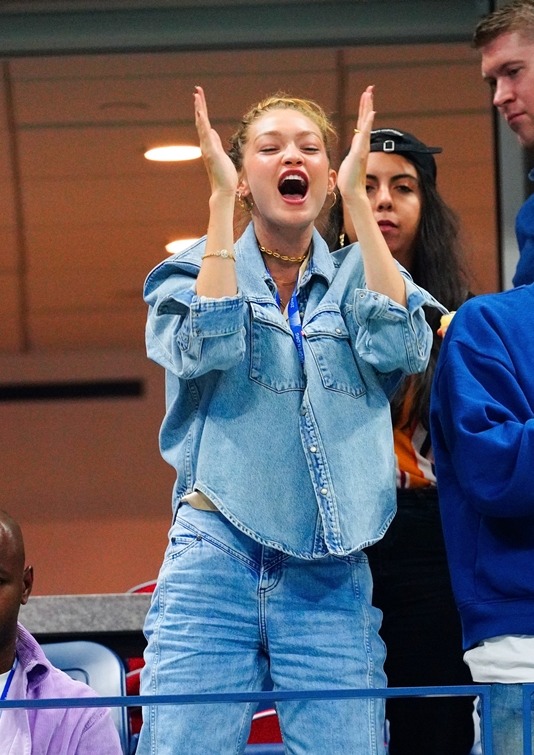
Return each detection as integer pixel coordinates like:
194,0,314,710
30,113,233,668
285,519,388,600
344,152,422,270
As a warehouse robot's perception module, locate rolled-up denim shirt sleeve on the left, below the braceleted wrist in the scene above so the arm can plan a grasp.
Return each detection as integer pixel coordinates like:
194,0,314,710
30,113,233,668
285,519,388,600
145,263,245,380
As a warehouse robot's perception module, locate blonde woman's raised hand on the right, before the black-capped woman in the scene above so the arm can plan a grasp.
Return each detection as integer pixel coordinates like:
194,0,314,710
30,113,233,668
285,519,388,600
337,86,375,203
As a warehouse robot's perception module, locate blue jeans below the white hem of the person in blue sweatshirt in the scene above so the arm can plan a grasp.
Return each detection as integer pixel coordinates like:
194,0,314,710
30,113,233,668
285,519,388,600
484,684,534,755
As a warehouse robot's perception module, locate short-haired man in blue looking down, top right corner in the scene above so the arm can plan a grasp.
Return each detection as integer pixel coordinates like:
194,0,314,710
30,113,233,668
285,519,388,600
473,0,534,286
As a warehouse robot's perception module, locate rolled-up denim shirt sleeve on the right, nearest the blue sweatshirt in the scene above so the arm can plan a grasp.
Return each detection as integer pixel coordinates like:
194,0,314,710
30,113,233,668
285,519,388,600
353,273,447,374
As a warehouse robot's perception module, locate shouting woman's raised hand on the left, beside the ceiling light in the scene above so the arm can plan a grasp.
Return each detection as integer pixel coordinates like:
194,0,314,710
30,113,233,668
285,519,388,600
193,86,238,196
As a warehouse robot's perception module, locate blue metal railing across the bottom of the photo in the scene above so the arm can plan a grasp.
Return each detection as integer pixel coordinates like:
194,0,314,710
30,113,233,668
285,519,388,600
0,684,534,755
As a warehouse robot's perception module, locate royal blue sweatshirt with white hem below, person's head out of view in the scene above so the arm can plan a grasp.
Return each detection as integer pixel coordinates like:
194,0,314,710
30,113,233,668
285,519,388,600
431,285,534,649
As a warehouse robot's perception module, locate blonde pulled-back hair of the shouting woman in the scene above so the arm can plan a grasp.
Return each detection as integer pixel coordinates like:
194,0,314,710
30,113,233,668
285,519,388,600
228,92,337,171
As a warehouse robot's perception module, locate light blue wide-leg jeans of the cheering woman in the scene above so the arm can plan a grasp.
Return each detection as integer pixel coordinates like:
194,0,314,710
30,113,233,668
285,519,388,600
137,504,386,755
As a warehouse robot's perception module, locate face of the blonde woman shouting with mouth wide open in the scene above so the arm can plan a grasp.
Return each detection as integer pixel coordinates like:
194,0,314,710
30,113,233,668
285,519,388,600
238,109,336,232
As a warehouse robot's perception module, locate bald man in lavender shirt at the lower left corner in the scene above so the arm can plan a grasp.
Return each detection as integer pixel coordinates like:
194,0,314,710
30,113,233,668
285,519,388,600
0,510,122,755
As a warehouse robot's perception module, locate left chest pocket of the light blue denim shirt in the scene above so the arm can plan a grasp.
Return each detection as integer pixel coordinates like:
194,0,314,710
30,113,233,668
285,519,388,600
249,302,306,393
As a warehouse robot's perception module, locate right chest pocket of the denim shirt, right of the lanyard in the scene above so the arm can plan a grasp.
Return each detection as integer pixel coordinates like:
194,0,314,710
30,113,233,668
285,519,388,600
303,308,367,398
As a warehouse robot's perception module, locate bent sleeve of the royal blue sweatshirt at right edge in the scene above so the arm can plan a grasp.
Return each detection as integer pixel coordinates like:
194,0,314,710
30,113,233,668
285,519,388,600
431,294,534,517
